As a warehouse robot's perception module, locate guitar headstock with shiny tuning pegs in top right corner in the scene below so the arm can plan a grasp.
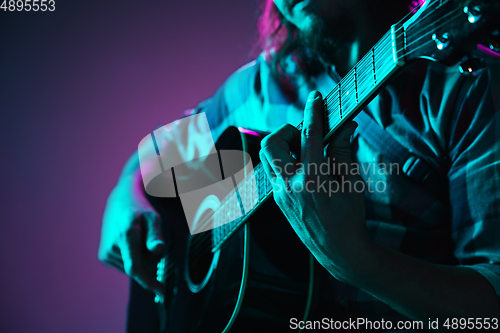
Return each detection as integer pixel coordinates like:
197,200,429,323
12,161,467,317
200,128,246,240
403,0,500,65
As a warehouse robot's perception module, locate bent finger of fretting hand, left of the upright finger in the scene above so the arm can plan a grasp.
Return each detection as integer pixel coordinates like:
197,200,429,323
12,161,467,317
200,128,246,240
261,124,300,178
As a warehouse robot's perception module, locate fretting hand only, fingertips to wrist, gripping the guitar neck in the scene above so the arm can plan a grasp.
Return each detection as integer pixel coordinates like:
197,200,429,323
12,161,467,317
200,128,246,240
260,92,371,280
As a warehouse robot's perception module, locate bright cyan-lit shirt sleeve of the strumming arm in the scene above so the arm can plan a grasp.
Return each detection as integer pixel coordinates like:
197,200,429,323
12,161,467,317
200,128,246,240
138,61,260,197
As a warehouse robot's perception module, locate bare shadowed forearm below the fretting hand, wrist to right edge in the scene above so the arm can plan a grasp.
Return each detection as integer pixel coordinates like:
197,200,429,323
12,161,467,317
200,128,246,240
344,245,500,323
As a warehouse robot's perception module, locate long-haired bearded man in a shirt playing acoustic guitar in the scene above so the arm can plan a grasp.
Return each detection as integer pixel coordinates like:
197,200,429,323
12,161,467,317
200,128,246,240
99,0,500,329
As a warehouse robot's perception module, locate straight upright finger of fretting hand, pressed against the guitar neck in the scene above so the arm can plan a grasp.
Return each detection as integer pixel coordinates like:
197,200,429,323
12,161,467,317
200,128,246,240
301,91,324,165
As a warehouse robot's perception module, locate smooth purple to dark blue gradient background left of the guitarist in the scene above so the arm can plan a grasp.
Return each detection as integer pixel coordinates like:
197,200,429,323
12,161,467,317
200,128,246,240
0,0,257,333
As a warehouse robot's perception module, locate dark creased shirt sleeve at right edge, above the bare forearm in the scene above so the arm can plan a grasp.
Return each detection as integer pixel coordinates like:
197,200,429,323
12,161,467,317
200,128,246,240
449,62,500,300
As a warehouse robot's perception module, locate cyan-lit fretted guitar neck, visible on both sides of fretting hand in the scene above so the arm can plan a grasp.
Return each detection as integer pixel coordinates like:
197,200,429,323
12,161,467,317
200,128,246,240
212,24,406,252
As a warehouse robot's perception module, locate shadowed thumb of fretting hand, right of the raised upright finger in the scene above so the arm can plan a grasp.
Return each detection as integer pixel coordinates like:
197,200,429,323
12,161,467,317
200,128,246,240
327,121,358,176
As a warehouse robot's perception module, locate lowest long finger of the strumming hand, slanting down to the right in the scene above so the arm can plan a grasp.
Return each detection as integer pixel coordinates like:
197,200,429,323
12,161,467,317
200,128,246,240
120,229,164,294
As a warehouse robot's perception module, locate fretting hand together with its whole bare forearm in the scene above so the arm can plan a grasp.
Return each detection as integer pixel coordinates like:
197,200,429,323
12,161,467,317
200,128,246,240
260,92,500,322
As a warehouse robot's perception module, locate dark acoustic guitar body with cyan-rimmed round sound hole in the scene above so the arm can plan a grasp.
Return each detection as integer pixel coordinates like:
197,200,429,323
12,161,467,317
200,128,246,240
149,127,315,333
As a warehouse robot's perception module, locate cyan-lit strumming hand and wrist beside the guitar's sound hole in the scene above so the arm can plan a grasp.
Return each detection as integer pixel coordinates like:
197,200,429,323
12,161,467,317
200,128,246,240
98,172,165,295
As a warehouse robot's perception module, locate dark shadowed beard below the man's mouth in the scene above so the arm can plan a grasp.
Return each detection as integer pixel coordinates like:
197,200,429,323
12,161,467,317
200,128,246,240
297,10,357,66
